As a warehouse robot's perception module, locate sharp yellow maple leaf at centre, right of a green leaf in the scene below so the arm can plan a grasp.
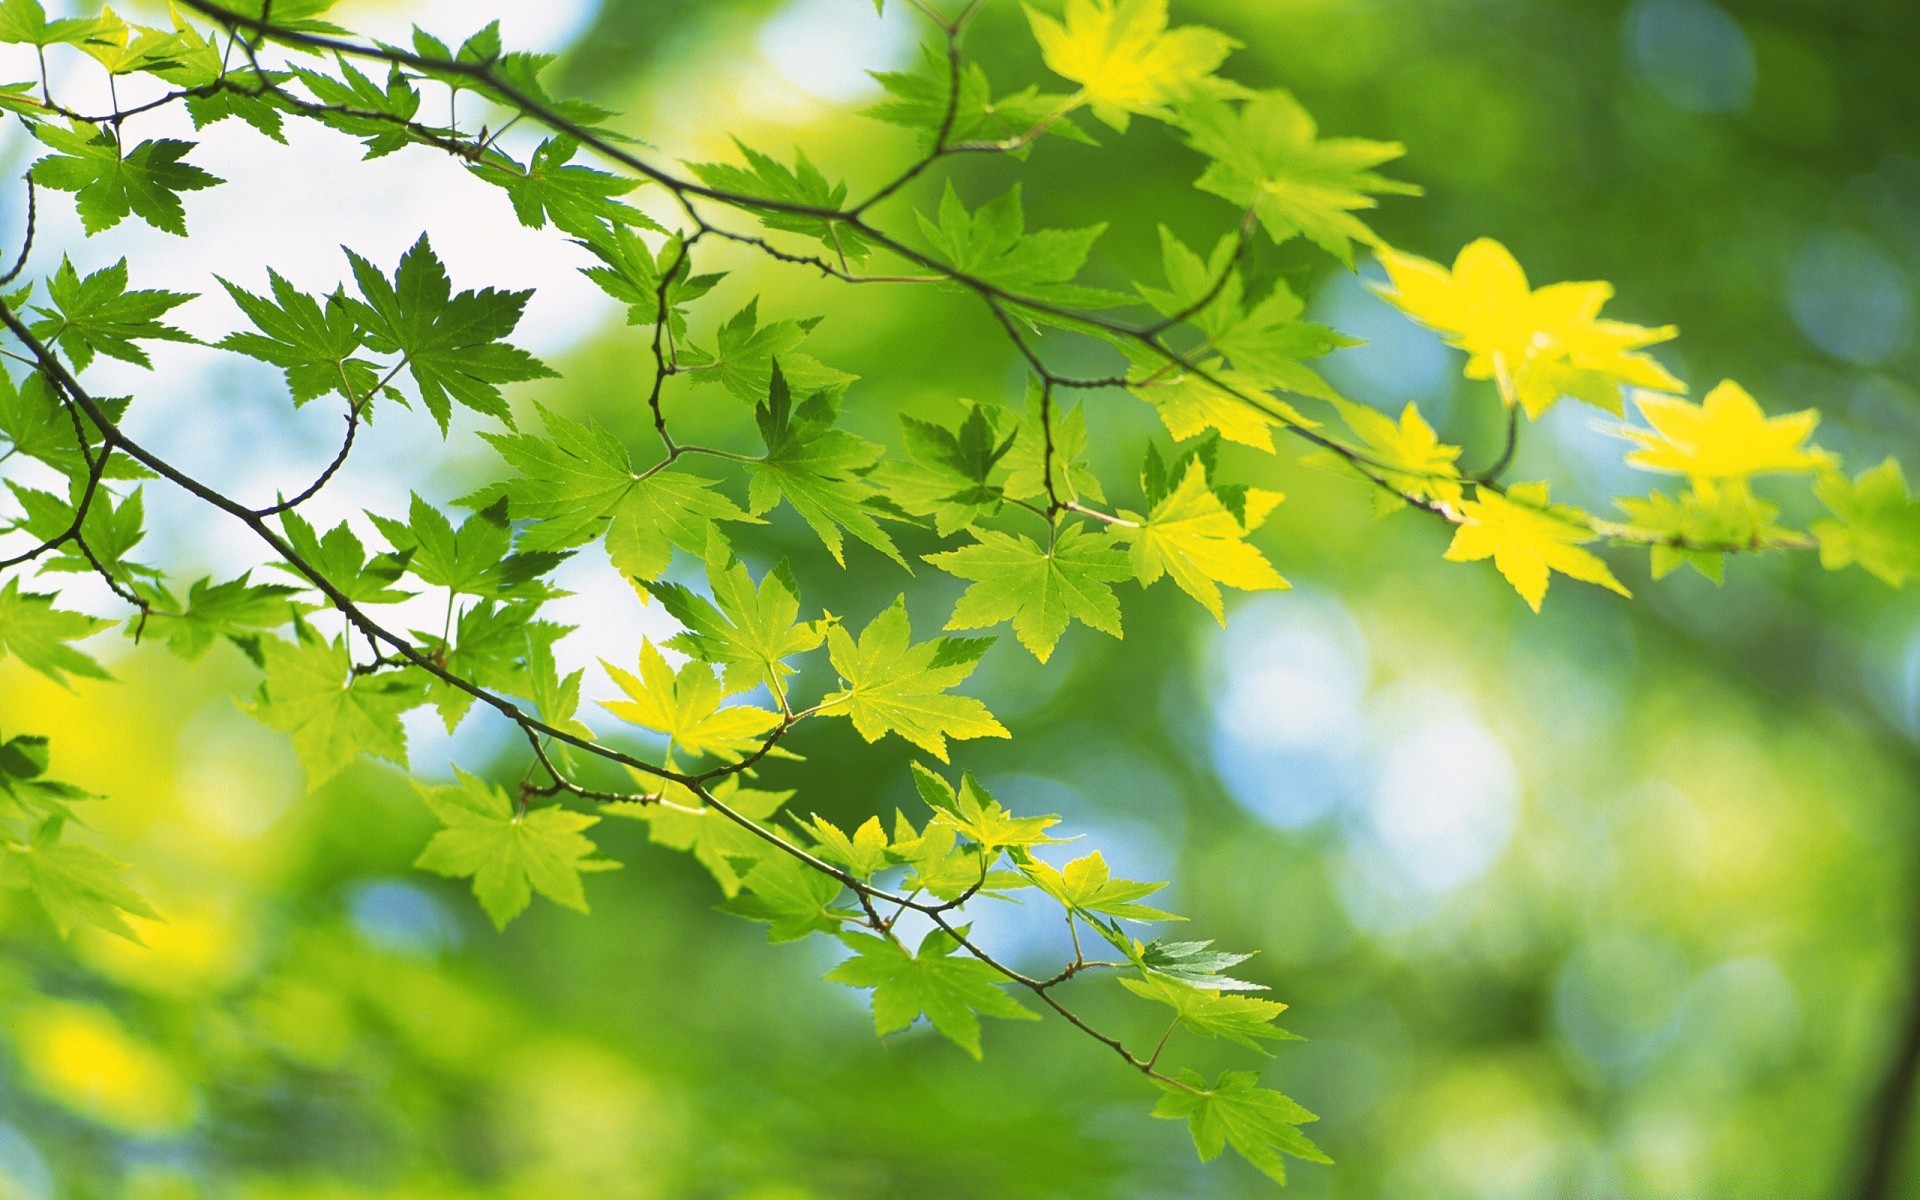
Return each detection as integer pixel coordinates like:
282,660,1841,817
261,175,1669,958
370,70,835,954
1114,461,1290,624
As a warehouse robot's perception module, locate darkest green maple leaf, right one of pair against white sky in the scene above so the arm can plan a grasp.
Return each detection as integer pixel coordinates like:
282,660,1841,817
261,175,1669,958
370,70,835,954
346,234,553,432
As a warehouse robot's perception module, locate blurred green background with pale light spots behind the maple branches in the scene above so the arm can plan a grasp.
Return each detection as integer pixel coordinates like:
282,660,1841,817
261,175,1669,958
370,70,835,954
0,0,1920,1200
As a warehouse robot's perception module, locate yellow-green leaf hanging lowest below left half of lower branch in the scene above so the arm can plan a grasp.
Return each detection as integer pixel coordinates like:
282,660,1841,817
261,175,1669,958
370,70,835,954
413,768,620,929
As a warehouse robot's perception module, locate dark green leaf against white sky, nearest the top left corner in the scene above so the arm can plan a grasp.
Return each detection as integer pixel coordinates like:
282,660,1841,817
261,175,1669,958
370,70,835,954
33,123,225,238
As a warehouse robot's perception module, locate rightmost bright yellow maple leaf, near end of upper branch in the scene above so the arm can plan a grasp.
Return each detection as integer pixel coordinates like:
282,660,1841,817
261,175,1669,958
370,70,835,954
1617,380,1834,488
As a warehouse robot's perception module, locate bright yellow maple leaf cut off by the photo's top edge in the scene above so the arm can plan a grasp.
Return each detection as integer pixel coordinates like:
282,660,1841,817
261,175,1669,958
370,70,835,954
1027,0,1238,131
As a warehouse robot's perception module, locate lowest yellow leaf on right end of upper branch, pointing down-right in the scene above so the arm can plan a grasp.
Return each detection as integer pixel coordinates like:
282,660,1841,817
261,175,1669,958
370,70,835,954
1446,484,1632,612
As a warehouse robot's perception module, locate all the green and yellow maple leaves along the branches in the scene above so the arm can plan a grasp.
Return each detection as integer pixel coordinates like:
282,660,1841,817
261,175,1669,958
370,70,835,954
0,0,1920,1179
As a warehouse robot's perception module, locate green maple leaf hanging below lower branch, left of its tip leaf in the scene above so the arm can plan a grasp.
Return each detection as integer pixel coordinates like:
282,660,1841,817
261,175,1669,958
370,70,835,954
828,929,1039,1058
